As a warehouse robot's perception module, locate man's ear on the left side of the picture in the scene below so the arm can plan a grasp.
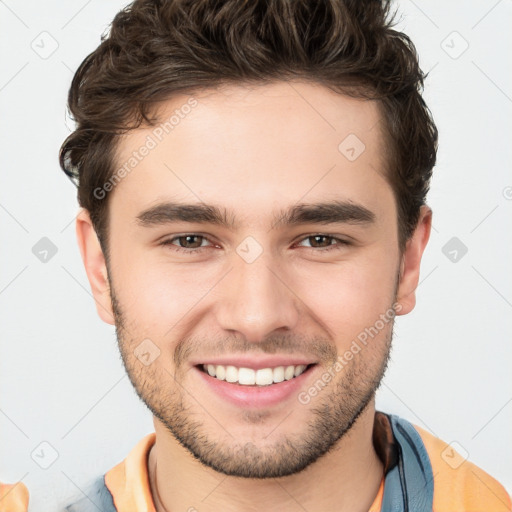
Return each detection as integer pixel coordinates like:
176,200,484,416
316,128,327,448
76,208,115,325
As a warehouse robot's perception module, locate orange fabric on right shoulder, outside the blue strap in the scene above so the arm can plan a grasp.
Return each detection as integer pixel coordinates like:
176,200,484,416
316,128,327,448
413,425,512,512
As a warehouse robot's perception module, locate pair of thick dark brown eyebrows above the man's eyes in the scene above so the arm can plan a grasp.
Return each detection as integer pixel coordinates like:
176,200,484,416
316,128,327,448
136,200,375,230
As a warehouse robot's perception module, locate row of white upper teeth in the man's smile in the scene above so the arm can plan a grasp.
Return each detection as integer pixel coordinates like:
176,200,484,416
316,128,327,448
203,364,306,386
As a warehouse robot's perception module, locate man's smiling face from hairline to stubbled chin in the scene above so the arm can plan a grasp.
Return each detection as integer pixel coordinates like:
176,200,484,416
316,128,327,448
79,82,428,478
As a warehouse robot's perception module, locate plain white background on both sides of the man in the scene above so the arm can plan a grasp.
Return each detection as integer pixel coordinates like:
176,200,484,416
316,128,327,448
0,0,512,511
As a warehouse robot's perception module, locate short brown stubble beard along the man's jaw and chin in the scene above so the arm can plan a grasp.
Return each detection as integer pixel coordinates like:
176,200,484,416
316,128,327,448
111,286,393,479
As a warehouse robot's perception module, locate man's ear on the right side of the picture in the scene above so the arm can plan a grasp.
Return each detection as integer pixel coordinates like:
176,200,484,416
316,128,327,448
396,205,432,315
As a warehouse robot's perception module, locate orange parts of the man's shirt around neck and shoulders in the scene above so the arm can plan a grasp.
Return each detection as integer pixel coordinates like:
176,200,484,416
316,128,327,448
0,412,512,512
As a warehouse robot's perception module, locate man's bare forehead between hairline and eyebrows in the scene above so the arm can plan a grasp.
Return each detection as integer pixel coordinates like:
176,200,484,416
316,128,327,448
110,81,392,224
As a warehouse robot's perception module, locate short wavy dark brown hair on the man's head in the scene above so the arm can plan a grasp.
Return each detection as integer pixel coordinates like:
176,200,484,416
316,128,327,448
60,0,437,259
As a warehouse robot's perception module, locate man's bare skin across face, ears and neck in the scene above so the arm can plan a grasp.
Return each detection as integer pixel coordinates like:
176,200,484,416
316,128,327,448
76,81,432,512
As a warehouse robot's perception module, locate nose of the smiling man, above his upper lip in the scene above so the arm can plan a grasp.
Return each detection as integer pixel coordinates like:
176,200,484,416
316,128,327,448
216,252,300,343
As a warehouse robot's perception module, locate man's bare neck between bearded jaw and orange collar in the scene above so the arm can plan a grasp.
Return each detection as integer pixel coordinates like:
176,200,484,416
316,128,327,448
148,401,383,512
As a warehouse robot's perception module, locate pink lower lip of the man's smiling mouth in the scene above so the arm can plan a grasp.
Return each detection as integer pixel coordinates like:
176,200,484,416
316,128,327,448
194,365,316,407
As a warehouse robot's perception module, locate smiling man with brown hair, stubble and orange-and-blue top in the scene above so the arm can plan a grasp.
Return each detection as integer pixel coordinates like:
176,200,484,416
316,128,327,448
2,0,512,512
